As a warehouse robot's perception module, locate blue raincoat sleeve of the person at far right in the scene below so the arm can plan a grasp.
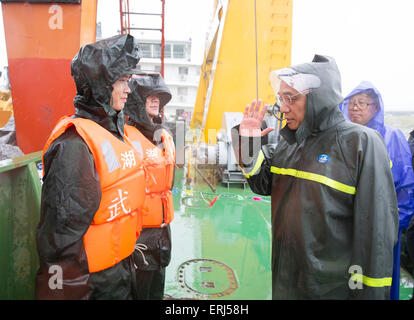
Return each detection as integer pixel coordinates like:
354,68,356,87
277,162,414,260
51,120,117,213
387,130,414,230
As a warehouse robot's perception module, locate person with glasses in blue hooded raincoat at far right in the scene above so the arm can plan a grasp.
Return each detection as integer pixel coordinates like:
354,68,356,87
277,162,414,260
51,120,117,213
339,81,414,299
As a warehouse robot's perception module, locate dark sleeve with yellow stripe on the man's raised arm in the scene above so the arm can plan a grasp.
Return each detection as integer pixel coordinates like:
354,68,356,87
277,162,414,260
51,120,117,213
231,126,275,196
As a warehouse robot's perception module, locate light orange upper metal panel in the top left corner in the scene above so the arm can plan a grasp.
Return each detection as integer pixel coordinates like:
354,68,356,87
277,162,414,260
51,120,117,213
2,3,81,59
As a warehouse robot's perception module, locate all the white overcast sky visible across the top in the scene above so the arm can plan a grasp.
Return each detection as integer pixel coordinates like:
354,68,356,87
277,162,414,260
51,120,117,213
0,0,414,112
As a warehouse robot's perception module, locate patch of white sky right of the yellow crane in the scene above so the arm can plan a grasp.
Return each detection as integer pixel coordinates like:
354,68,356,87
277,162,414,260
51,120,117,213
292,0,414,112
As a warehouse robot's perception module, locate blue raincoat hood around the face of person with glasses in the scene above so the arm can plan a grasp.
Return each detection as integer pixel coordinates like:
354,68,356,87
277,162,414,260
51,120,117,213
339,81,385,136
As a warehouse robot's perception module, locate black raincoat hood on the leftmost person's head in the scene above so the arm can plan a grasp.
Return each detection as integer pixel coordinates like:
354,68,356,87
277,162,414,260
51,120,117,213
71,34,141,136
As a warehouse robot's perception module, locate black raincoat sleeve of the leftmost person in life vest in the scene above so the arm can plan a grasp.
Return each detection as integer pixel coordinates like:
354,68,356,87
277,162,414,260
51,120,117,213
36,128,101,299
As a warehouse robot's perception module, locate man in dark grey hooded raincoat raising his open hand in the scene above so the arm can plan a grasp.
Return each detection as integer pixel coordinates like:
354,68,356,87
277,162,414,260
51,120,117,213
232,55,398,299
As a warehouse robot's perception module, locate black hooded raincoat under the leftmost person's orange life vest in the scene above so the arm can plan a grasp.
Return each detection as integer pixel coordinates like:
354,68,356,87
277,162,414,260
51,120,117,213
36,35,140,299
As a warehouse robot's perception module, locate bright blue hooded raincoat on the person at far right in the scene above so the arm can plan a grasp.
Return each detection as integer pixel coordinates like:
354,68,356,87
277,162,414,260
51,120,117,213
339,81,414,230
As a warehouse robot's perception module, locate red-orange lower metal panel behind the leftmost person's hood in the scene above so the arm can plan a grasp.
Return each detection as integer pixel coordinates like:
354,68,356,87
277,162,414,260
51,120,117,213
9,58,76,153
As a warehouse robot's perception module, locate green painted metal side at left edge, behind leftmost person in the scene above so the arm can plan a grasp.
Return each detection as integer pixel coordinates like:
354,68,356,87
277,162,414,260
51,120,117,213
0,152,41,299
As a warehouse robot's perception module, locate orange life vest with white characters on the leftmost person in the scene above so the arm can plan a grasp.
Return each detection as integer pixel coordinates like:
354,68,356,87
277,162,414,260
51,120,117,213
42,116,145,273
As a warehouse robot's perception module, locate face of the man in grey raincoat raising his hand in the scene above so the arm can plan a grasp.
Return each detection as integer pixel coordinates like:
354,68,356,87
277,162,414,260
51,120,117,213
278,81,306,130
